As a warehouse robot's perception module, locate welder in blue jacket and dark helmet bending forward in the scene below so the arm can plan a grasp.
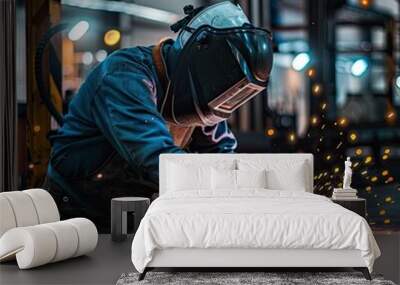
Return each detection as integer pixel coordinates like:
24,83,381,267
48,1,272,231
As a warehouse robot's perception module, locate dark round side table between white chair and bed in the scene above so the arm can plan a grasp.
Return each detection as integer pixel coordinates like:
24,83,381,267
111,197,150,241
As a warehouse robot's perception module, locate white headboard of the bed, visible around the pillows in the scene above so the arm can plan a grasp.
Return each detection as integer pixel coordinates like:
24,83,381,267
159,153,314,195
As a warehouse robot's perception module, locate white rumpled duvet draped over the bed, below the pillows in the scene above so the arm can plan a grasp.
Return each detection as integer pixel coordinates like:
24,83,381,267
132,189,380,272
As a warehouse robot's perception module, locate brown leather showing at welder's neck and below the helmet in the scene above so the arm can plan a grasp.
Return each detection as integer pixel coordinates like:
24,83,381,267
152,39,194,148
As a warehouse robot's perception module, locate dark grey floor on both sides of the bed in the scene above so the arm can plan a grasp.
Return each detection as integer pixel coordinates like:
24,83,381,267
0,230,400,285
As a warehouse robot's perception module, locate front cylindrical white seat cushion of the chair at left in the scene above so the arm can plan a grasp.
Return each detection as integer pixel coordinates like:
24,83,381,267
0,218,97,269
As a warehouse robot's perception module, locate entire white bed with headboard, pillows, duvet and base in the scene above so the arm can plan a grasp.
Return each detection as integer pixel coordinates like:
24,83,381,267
132,154,380,278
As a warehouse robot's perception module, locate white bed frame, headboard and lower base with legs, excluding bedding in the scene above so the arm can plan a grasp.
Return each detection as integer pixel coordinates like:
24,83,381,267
139,154,371,280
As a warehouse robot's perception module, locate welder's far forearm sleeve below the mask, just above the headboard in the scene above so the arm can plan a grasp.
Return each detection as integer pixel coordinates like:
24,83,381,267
188,121,237,153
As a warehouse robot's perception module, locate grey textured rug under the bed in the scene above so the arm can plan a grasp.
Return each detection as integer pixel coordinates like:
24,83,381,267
117,272,395,285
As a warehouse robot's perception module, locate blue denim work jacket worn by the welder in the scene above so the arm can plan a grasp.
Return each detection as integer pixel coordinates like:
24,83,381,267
48,47,236,189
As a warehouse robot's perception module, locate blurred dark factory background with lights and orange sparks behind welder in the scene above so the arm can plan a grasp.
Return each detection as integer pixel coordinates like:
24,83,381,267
0,0,400,228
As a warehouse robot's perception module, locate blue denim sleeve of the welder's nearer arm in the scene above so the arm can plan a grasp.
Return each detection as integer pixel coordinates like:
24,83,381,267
92,69,183,183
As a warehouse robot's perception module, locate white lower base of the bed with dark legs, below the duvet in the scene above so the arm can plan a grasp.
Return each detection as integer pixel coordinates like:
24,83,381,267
139,248,371,280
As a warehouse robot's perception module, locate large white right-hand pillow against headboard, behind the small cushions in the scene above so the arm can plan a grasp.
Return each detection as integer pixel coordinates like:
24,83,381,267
238,159,310,191
